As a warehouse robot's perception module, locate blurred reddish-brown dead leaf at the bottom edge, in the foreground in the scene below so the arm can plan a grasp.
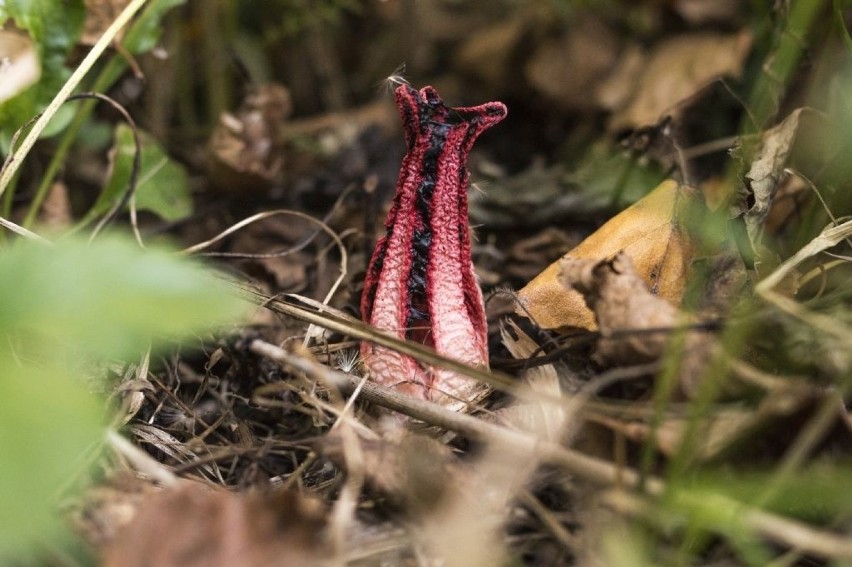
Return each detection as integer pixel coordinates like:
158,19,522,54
103,482,325,567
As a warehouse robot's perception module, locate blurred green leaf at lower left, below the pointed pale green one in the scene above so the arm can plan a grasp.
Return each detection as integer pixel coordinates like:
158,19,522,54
0,358,104,565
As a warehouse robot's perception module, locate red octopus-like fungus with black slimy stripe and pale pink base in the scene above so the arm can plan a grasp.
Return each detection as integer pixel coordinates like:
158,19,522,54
361,84,506,409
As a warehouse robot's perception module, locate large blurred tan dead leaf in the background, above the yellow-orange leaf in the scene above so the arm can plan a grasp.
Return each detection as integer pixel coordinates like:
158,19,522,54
600,31,751,130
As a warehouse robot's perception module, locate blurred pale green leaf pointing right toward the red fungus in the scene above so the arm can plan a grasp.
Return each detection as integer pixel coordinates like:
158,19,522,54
0,236,246,356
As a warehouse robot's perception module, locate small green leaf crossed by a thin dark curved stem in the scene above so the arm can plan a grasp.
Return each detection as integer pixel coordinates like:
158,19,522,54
90,124,192,222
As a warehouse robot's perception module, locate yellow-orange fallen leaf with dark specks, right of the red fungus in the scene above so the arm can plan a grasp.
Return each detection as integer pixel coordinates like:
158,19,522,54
518,181,693,329
